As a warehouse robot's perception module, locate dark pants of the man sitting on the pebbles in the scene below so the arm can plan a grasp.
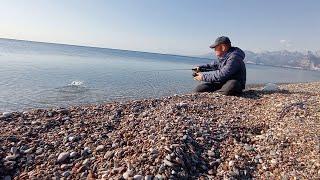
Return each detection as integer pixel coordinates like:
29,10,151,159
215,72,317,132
194,80,242,96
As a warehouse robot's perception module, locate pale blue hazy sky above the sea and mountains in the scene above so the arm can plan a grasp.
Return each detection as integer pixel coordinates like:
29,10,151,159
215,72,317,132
0,0,320,55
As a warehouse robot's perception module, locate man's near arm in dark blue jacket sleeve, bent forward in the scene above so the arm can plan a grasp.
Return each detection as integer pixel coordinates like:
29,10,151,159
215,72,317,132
202,58,240,82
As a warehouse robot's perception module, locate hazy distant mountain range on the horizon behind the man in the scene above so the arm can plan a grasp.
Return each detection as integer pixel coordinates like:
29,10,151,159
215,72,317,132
200,50,320,71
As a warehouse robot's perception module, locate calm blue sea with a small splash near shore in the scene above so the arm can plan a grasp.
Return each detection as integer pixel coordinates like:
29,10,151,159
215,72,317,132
0,38,320,112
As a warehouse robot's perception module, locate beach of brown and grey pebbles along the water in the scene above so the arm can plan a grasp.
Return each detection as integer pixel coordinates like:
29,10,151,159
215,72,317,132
0,82,320,180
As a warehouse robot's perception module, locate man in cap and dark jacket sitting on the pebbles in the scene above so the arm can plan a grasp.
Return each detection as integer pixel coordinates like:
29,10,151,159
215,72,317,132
194,36,246,95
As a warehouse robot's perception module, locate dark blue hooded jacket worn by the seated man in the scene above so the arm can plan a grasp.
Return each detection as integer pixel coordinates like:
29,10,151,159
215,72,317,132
200,47,246,89
